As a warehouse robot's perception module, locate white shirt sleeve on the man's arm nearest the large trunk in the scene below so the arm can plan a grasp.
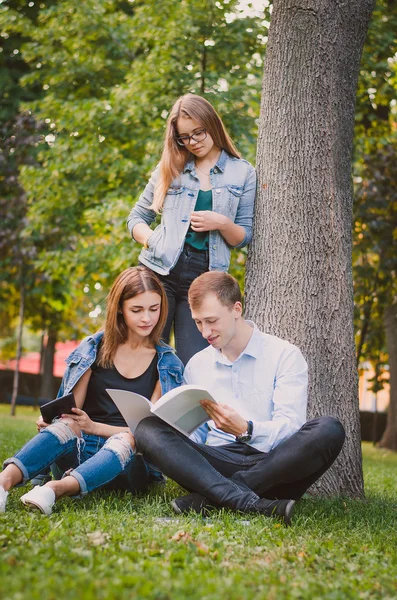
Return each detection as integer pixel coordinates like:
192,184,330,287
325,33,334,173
250,345,308,452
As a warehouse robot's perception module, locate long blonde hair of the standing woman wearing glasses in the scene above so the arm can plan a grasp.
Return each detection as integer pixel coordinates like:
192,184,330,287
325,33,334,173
150,94,240,213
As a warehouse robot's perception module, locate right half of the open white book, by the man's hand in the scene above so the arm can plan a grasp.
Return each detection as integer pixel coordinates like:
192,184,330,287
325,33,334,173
152,385,216,435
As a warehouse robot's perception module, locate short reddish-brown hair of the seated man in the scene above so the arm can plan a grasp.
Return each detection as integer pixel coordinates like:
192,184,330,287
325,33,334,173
188,271,242,309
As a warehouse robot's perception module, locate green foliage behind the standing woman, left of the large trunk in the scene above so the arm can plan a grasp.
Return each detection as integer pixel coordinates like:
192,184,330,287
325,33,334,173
0,0,266,346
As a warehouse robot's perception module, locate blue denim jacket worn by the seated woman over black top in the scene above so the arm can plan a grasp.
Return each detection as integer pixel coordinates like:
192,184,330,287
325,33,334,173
57,331,183,398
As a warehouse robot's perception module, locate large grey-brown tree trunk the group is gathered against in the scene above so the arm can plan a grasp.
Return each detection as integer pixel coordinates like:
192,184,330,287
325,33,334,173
245,0,373,497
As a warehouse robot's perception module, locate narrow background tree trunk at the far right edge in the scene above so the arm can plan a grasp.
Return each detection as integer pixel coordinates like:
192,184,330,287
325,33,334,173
379,304,397,452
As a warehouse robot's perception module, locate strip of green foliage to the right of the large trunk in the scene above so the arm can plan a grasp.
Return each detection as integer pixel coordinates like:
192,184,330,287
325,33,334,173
353,0,397,382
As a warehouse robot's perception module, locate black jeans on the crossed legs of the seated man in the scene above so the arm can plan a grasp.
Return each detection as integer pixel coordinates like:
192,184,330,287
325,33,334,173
135,417,345,512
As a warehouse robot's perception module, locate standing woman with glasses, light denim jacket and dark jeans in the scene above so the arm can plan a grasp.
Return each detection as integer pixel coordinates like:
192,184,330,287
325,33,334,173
128,94,256,364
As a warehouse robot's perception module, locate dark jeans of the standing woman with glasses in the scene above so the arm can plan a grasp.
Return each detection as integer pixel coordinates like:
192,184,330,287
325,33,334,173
158,244,208,365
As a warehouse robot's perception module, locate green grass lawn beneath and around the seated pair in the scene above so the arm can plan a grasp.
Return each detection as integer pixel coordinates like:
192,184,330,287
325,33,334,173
0,406,397,600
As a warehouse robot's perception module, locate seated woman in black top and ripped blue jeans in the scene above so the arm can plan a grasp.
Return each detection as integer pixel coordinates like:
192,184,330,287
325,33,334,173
0,267,183,515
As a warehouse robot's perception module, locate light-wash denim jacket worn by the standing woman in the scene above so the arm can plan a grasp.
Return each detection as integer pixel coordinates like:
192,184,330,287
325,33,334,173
127,150,256,275
